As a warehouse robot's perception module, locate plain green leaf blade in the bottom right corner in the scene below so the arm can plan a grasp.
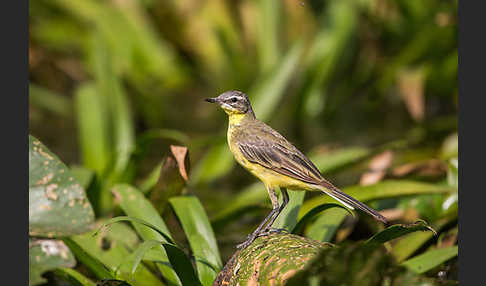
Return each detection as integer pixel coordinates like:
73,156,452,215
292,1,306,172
401,245,458,274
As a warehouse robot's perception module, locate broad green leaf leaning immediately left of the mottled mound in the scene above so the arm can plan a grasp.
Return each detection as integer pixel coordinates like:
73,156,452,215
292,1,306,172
169,196,222,285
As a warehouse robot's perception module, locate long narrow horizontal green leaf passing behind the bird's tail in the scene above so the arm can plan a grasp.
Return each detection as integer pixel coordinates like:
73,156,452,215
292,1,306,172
299,180,453,217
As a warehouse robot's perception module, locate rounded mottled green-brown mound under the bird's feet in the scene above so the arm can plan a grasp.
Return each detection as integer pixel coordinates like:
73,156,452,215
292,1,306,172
213,233,333,286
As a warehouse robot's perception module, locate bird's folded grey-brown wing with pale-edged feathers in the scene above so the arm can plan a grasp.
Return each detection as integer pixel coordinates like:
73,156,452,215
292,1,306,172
237,126,323,184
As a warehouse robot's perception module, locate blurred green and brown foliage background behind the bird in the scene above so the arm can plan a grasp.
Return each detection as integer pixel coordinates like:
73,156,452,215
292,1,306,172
29,0,458,274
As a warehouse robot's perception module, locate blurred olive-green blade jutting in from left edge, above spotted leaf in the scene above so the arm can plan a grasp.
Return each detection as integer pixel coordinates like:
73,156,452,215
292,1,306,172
29,84,73,118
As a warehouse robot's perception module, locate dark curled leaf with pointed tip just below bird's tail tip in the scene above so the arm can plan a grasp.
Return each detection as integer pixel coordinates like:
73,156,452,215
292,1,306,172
366,220,437,245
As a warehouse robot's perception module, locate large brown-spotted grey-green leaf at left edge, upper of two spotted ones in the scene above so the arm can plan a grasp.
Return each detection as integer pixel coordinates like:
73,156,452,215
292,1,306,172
29,135,94,237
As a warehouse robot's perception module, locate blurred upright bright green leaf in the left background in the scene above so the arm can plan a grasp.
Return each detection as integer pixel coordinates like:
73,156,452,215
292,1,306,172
74,83,110,176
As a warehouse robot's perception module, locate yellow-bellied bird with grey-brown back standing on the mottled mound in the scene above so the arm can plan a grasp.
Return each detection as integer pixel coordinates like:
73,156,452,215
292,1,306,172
205,90,388,249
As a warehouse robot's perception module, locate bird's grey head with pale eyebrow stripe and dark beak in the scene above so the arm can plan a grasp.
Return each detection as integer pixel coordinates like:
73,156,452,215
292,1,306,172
206,90,255,116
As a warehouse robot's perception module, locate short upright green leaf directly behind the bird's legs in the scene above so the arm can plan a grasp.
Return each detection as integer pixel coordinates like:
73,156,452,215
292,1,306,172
272,190,305,231
